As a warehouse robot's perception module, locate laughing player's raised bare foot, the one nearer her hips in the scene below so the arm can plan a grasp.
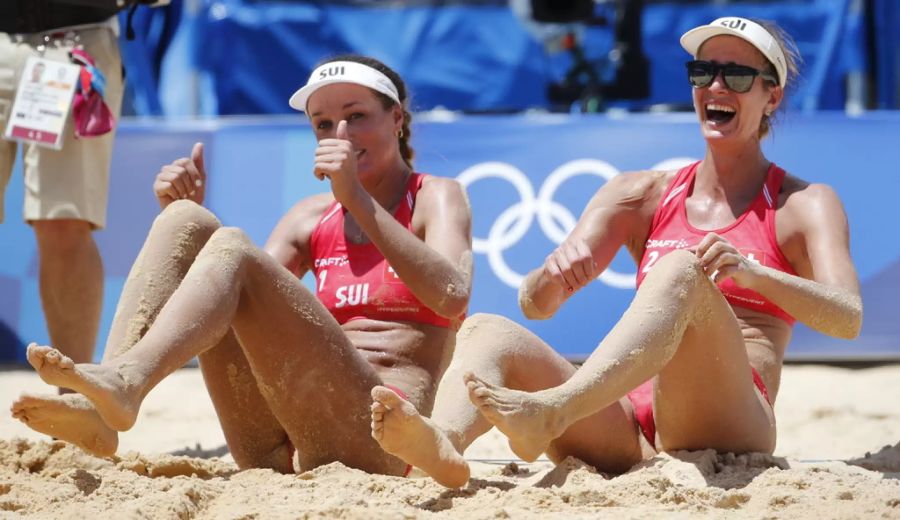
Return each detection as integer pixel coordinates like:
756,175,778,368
463,372,565,462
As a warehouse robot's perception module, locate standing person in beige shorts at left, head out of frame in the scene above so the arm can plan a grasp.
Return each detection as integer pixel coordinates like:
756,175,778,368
0,0,123,370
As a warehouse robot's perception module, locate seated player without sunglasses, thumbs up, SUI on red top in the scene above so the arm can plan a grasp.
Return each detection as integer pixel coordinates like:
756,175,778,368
12,56,472,475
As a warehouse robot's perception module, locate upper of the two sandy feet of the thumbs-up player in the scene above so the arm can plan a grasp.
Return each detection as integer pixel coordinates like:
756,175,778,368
25,343,140,432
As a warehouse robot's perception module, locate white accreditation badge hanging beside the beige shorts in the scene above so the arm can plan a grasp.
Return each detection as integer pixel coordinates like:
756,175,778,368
4,57,81,150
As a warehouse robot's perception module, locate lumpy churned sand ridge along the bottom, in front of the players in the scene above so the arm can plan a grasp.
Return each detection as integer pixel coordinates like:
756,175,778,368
0,439,900,518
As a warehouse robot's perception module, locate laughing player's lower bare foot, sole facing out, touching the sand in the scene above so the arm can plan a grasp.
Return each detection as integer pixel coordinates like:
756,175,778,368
371,386,469,488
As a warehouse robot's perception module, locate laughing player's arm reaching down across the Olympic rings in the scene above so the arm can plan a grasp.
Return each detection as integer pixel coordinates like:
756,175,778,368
519,172,668,319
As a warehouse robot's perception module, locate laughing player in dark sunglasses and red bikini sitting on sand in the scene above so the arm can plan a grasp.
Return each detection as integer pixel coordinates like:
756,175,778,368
373,17,862,486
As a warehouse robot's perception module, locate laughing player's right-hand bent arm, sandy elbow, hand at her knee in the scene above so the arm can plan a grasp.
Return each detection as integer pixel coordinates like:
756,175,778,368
697,184,862,339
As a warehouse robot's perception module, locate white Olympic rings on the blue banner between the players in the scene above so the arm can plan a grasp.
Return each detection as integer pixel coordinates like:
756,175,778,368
456,157,695,289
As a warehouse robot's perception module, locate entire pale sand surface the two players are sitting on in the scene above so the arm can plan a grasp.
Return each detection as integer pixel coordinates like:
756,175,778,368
0,365,900,519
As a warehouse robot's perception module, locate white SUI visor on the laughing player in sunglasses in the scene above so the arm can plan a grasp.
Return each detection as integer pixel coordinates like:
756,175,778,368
681,16,787,88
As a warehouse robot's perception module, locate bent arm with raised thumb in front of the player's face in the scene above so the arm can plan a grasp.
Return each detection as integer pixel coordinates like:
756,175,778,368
315,121,472,318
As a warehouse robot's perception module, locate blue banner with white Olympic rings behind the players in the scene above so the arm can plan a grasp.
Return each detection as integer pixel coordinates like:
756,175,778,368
0,113,900,362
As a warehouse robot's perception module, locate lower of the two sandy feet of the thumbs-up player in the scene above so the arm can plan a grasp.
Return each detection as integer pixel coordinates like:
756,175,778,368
10,394,119,457
